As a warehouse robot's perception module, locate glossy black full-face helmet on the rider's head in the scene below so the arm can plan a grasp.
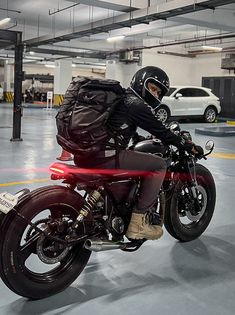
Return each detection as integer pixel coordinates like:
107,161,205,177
130,66,169,109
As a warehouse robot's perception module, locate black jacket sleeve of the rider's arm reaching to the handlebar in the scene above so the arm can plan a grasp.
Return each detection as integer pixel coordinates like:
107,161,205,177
128,98,193,151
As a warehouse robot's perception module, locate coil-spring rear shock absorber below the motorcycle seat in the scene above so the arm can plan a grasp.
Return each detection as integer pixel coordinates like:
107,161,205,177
74,187,104,228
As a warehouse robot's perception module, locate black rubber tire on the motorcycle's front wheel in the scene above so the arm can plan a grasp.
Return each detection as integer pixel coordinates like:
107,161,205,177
164,164,216,242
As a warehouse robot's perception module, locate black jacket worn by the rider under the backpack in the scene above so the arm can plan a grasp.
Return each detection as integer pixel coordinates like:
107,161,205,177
74,89,193,167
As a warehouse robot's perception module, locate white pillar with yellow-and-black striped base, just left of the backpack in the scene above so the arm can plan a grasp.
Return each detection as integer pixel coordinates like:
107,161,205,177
54,59,72,105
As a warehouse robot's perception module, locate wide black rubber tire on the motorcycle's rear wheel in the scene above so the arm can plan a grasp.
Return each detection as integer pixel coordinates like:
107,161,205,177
0,186,92,299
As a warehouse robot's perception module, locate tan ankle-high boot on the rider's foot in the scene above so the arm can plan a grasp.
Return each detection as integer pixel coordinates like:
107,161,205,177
126,213,163,240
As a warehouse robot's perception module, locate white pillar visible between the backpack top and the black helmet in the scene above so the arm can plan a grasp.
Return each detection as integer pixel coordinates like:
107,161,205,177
105,60,141,88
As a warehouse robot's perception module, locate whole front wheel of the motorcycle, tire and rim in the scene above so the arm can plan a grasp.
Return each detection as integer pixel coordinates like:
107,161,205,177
164,164,216,242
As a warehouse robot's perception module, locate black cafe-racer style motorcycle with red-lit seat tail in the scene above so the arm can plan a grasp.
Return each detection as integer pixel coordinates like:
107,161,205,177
0,123,216,299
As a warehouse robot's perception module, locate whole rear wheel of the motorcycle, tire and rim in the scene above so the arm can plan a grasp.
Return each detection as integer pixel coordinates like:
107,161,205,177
0,186,92,299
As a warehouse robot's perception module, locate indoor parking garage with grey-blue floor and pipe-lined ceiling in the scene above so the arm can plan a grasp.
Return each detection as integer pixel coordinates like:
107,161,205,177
0,0,235,315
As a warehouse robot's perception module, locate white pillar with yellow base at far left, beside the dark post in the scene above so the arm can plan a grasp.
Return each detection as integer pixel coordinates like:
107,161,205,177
3,60,14,103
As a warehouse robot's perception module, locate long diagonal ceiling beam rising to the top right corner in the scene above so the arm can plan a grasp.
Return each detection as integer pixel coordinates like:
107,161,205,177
25,0,234,47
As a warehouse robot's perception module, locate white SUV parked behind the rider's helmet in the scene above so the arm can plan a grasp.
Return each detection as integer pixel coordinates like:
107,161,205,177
155,86,221,123
